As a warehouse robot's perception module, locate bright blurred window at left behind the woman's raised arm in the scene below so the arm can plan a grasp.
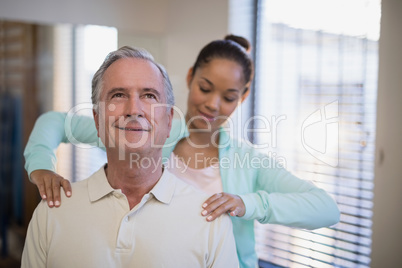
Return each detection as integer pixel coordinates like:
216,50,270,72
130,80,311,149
54,25,117,181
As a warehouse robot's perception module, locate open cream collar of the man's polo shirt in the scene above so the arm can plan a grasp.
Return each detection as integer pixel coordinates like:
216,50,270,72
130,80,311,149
88,166,176,204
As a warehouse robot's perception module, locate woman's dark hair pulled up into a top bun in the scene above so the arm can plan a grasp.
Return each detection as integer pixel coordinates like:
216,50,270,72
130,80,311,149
192,35,254,94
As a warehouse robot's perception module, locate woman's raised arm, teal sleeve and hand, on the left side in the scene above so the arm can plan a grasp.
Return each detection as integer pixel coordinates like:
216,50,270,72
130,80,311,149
24,112,99,207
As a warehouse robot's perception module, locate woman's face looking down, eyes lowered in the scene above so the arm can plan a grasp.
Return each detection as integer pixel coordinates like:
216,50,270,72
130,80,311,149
186,59,248,131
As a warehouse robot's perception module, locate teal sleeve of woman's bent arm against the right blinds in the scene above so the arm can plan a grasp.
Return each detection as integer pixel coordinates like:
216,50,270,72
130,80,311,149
240,154,340,229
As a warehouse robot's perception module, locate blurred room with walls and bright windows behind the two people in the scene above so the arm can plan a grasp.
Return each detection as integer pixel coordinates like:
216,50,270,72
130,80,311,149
0,0,402,267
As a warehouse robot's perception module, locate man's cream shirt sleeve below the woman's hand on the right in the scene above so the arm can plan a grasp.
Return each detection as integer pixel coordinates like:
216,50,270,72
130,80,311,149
207,215,239,268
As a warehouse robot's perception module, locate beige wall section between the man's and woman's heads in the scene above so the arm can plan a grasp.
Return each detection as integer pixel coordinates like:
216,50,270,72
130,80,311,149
164,0,229,113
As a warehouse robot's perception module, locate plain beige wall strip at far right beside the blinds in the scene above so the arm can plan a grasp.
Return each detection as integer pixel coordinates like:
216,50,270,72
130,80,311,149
371,0,402,268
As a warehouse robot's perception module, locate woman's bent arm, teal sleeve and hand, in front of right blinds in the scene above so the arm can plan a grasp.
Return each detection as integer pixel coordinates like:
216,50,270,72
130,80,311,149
202,144,340,229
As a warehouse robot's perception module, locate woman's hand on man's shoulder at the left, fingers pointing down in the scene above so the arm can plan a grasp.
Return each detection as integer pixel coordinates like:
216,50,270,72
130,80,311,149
31,169,72,207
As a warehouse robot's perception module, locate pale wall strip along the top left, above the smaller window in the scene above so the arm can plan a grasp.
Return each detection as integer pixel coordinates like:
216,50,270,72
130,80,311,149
0,0,168,33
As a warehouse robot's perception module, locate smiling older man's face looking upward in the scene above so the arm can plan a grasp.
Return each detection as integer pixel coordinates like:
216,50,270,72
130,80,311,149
94,58,173,159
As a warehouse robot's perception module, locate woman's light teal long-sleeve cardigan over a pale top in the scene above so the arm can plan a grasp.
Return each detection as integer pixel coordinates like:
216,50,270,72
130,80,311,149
24,112,340,267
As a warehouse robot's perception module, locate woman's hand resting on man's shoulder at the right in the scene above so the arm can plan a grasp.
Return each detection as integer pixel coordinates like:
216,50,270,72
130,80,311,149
201,193,246,221
